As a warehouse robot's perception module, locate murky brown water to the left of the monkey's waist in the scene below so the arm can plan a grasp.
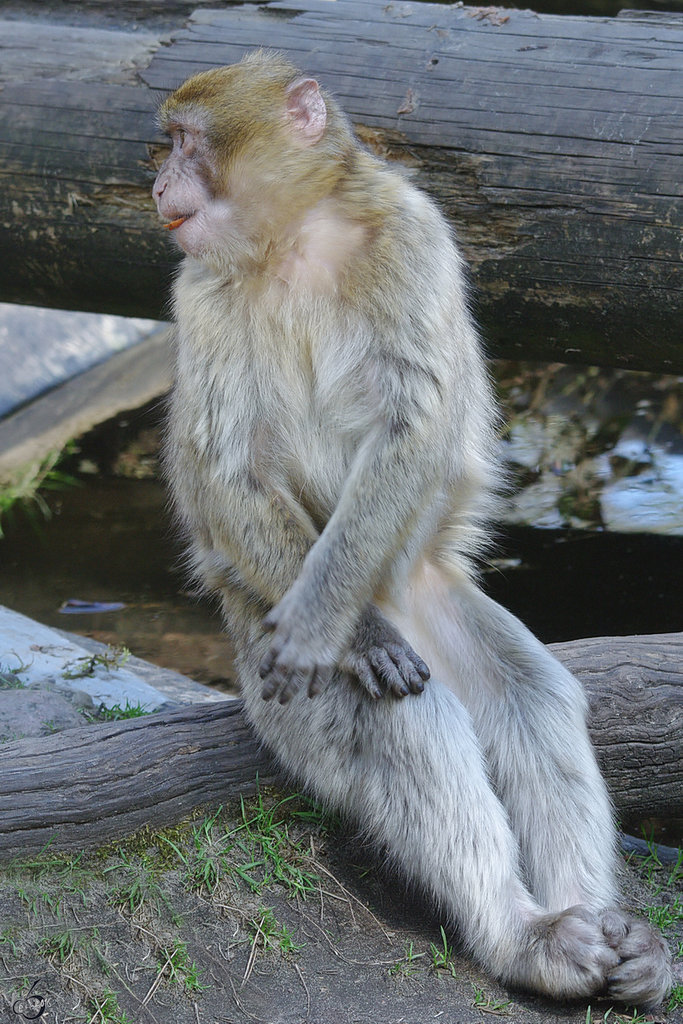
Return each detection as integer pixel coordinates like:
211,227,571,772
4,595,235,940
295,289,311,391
0,476,235,682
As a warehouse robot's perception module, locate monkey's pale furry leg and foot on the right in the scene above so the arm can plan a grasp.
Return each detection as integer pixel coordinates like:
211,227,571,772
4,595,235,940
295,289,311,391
389,569,671,1005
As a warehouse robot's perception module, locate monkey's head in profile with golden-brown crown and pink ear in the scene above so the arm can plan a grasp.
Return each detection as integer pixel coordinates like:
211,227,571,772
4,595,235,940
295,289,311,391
154,54,337,269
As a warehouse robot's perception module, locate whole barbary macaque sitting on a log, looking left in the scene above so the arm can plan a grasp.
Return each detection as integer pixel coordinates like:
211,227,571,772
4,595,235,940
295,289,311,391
154,52,671,1007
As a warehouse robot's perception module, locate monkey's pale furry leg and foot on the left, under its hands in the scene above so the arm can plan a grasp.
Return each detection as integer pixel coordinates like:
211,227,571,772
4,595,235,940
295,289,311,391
240,635,634,997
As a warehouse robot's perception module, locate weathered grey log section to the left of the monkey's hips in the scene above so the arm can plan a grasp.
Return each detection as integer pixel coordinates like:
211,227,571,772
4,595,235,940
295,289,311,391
0,700,275,856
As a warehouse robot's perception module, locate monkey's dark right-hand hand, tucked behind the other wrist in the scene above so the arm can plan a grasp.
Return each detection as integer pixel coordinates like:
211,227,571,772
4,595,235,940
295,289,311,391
339,604,429,700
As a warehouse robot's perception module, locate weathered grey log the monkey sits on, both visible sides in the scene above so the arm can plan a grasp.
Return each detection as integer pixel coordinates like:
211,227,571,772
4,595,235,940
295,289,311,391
0,634,683,857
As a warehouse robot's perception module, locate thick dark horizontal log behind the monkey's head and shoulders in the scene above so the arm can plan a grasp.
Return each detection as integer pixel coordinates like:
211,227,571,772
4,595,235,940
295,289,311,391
0,0,683,372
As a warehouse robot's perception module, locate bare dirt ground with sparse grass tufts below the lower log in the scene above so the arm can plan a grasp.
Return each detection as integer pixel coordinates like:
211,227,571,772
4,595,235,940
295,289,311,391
0,793,683,1024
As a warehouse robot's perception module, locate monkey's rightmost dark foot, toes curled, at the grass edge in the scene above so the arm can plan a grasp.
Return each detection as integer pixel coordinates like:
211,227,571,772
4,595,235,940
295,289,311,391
600,910,673,1008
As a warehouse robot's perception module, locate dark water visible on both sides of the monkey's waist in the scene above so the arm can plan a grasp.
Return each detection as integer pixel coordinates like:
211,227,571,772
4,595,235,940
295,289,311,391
0,476,683,667
